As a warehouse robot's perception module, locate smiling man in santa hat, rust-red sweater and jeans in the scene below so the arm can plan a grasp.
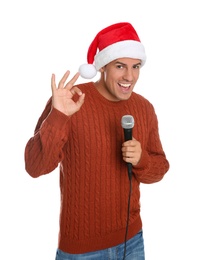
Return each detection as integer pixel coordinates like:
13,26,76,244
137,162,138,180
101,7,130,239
25,23,169,260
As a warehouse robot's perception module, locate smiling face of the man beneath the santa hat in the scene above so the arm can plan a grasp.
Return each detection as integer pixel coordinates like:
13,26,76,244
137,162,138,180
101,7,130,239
95,58,141,101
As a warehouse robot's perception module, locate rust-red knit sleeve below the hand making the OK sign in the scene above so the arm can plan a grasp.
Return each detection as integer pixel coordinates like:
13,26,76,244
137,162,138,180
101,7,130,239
25,99,69,178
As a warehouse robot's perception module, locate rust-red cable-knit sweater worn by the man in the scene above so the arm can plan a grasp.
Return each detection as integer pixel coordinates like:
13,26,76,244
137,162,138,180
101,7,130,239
25,82,169,253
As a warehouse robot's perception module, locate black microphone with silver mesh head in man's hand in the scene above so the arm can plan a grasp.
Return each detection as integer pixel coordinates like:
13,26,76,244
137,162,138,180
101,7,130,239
121,115,134,180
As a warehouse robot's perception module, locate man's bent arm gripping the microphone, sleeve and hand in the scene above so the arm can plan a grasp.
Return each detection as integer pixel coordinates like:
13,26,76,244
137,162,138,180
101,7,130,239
122,106,169,183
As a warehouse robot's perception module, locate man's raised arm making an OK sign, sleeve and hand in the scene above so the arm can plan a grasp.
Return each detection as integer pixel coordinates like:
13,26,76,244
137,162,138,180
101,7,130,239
25,71,85,177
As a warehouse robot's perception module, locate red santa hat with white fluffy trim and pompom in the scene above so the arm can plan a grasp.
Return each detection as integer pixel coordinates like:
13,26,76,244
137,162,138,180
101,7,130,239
79,22,146,79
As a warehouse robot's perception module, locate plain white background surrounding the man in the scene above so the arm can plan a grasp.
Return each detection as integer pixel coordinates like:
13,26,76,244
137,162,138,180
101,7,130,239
0,0,197,260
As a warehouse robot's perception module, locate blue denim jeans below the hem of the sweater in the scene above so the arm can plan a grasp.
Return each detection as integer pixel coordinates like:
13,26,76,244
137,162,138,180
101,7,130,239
55,230,145,260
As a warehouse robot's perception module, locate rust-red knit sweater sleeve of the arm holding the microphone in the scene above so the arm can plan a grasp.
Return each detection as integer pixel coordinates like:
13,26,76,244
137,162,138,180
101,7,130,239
133,104,170,184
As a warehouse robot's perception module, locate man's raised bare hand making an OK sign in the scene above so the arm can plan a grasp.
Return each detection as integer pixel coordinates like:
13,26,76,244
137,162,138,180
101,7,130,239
51,71,85,116
